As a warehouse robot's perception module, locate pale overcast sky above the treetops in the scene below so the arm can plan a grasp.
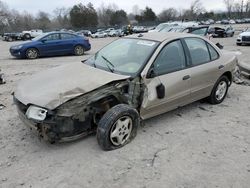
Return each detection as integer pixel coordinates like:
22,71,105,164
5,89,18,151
2,0,225,14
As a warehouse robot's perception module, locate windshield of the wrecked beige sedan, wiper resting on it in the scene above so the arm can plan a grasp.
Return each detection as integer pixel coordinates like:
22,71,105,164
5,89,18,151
85,38,159,76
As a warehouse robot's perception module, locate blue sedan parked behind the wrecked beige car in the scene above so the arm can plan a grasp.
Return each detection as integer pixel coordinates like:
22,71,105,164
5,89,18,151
10,32,91,59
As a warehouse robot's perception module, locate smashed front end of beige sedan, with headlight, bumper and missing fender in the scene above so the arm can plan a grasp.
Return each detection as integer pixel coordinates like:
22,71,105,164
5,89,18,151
14,77,143,143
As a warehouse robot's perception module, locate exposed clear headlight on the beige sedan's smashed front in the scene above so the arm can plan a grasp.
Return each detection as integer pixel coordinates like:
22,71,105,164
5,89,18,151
26,106,48,121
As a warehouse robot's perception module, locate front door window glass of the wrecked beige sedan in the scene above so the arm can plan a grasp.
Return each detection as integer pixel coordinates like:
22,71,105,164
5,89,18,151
154,40,186,76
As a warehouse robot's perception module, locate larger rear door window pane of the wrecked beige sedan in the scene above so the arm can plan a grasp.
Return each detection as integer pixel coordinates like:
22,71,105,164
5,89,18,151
185,38,210,66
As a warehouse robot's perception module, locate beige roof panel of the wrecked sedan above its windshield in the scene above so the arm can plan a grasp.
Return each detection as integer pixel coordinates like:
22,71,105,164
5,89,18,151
126,32,201,42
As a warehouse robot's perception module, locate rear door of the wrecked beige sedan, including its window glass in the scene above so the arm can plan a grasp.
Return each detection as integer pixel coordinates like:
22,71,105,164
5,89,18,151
184,38,223,101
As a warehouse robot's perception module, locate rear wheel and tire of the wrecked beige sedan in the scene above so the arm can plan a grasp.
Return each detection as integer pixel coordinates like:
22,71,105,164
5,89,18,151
208,76,230,104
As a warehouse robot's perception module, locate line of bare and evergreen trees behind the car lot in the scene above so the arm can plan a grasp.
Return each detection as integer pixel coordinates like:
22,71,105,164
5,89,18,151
0,0,250,33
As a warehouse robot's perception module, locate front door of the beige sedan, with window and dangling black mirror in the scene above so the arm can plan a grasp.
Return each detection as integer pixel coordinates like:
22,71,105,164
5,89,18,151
141,40,191,119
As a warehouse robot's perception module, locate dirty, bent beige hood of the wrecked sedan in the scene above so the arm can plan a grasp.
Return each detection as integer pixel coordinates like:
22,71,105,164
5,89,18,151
14,63,129,110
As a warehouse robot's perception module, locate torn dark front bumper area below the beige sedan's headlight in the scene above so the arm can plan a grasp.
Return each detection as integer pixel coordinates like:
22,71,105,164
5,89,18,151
14,97,94,143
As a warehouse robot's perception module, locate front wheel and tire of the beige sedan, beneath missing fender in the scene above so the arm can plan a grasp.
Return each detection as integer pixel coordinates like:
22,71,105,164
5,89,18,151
97,104,140,151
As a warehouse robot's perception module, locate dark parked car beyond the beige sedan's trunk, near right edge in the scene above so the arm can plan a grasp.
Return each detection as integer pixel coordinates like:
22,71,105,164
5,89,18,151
208,26,235,37
